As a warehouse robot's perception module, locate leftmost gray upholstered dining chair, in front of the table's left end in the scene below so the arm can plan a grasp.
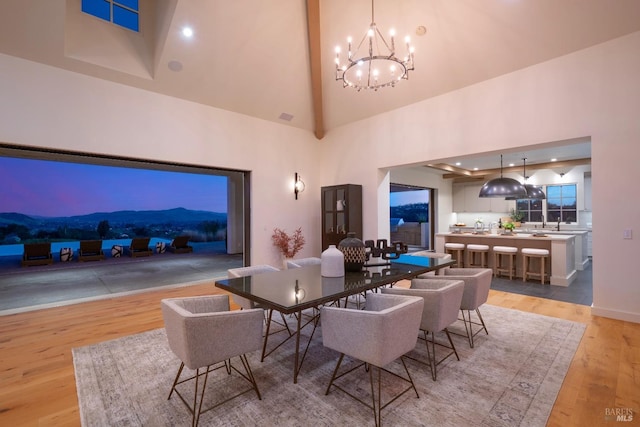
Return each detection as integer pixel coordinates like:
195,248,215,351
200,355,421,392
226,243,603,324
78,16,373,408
161,295,262,426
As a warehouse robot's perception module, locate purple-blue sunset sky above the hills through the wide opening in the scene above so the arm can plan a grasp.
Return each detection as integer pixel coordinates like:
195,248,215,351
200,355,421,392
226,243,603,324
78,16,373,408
0,157,227,217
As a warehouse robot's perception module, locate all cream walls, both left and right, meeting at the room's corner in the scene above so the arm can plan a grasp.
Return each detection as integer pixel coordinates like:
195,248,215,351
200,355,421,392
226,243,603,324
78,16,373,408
0,33,640,322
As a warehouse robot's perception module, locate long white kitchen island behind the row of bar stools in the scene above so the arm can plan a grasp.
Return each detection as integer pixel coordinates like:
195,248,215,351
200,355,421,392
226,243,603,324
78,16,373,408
435,232,577,286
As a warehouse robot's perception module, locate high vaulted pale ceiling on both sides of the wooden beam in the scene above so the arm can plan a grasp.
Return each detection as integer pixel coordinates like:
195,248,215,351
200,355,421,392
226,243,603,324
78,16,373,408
0,0,640,163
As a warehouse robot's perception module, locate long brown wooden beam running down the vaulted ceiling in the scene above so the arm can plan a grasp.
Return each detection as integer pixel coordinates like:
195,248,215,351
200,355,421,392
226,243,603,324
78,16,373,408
307,0,324,139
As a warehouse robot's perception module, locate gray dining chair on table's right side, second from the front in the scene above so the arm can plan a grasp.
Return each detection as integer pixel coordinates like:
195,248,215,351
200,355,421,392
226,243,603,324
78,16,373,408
382,279,464,381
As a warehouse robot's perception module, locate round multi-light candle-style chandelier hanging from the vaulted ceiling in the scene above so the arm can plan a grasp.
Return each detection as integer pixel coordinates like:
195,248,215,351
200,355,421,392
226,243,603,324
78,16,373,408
336,0,413,91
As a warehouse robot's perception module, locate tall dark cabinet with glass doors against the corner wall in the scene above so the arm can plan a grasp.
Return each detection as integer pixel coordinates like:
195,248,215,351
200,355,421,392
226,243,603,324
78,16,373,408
322,184,363,251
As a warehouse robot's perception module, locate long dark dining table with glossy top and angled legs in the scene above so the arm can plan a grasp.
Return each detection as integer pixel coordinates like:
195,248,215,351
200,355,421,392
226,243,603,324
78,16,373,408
215,255,455,383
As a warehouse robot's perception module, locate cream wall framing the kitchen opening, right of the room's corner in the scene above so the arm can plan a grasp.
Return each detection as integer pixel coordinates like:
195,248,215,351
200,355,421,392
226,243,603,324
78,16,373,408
322,32,640,322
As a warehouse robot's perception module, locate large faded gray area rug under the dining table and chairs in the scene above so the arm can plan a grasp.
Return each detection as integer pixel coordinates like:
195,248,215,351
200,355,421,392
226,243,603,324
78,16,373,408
73,304,585,426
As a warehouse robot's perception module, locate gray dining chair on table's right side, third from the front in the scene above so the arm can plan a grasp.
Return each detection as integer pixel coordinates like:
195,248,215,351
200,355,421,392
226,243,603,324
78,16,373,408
438,268,493,348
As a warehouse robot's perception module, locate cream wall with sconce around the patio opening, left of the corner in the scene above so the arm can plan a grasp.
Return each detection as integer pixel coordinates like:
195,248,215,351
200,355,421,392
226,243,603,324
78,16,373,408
0,55,320,265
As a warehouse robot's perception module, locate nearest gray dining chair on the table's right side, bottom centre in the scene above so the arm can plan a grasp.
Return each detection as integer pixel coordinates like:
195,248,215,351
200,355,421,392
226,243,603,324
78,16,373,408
321,294,424,426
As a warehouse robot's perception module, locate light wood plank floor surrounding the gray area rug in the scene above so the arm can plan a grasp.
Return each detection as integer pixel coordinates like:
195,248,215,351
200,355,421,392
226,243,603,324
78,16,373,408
0,285,640,427
